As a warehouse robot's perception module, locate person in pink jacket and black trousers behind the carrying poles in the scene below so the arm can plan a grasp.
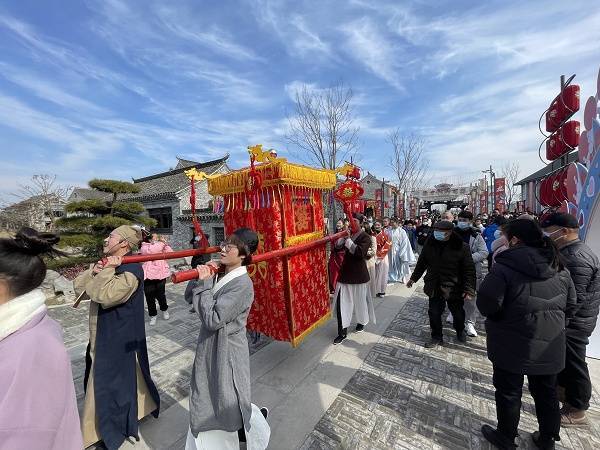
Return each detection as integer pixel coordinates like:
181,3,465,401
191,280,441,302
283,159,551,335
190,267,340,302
141,233,173,325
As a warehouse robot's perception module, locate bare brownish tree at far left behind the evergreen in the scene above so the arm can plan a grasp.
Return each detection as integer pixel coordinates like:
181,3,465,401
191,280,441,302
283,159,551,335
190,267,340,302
7,174,73,230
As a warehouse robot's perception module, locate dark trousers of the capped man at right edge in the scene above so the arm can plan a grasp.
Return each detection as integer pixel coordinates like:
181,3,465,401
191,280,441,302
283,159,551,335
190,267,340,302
558,331,592,410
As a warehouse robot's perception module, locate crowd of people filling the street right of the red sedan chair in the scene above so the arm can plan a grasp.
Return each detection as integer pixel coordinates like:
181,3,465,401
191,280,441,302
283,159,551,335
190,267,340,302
329,210,600,449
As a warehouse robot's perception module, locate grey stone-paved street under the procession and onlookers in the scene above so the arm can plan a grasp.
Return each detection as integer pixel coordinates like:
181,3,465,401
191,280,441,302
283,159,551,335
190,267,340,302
50,284,600,450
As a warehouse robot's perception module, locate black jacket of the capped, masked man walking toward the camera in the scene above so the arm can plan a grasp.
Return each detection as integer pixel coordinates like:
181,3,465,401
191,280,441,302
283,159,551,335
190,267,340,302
411,232,476,300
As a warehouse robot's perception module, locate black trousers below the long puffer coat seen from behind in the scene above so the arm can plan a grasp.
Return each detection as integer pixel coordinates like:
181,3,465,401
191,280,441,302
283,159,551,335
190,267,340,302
494,367,560,440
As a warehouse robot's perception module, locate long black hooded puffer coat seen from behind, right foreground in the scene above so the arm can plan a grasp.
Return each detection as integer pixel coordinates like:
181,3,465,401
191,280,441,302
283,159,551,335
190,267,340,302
477,246,576,375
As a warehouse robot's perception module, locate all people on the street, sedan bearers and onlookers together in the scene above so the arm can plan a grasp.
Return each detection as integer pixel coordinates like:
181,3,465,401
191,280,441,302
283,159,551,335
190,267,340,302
0,206,600,450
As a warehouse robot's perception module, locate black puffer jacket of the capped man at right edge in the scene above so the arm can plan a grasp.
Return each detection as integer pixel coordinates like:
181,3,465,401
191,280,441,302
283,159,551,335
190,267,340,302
560,239,600,337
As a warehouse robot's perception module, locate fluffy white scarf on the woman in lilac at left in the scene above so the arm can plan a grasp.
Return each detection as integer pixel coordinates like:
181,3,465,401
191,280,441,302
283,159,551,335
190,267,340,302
0,289,46,341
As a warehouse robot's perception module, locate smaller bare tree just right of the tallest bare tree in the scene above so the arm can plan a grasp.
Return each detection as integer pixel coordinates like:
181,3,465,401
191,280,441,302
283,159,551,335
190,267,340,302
387,128,429,193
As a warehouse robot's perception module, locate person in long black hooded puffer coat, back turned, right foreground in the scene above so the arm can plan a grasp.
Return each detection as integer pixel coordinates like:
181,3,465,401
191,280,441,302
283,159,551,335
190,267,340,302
477,219,576,449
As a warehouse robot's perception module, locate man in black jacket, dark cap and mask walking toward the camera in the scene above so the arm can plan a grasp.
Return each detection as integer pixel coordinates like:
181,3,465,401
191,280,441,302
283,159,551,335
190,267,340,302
406,220,475,348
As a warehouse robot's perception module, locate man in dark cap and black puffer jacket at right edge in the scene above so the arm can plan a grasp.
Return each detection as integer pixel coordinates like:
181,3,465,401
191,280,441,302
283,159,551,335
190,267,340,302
541,213,600,426
